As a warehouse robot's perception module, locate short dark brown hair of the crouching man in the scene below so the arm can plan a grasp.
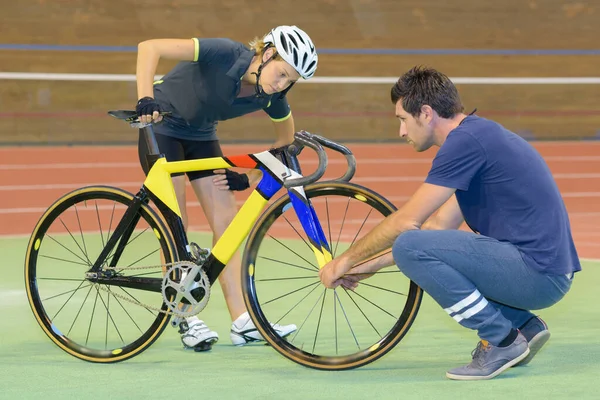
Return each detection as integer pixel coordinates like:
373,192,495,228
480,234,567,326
392,66,464,118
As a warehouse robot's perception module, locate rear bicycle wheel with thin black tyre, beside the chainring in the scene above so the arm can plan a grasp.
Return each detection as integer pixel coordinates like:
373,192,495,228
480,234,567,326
25,186,177,363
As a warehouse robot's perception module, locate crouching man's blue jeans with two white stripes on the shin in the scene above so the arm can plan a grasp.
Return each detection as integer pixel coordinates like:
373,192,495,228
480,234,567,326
392,230,571,346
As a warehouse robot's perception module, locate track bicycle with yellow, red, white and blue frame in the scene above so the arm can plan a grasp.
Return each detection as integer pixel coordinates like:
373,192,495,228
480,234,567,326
25,110,423,370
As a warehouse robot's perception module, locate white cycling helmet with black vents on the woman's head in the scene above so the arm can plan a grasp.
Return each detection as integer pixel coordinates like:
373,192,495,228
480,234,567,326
263,25,319,79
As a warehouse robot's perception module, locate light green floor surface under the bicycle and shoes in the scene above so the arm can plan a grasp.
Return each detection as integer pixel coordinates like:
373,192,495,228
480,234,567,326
0,234,600,400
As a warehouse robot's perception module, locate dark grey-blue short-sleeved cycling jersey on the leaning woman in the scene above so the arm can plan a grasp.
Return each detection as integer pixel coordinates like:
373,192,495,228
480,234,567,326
154,38,291,140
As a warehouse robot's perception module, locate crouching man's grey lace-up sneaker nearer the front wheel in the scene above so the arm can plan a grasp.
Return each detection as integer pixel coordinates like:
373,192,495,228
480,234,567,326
446,333,529,381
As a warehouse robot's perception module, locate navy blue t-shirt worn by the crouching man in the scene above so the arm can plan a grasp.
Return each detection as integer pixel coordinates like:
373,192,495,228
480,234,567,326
425,116,581,275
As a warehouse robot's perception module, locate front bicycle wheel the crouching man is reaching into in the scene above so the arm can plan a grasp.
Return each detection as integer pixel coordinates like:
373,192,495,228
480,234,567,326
242,182,423,370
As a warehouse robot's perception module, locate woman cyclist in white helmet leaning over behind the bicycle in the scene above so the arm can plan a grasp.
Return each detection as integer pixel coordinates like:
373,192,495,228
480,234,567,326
136,26,318,351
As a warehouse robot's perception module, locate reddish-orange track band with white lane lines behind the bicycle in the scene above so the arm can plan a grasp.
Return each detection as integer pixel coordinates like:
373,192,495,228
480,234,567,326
0,142,600,259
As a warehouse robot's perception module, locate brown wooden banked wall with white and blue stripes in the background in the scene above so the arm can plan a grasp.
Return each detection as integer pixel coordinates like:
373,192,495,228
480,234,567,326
0,0,600,143
